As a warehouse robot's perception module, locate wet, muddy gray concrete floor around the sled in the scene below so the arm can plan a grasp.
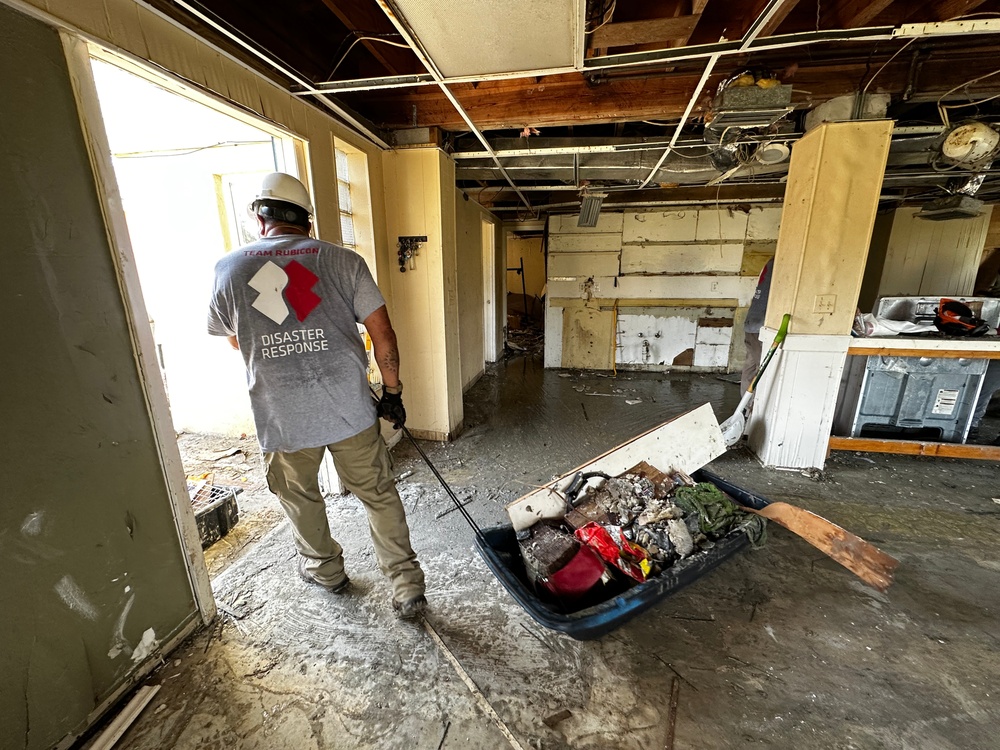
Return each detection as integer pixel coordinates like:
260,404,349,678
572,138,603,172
88,357,1000,750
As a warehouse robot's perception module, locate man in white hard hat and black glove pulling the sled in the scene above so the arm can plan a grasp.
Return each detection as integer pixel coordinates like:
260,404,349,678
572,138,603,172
208,172,426,617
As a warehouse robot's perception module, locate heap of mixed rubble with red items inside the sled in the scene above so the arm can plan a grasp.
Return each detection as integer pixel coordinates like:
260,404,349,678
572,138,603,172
518,464,765,604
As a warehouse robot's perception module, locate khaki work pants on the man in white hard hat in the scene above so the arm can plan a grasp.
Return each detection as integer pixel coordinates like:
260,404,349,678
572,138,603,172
264,422,424,602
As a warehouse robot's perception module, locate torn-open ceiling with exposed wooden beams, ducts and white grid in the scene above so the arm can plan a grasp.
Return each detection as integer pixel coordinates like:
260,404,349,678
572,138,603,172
147,0,1000,215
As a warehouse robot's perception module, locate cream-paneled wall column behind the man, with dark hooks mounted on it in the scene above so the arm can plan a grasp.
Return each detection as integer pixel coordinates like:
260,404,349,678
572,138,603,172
382,148,462,439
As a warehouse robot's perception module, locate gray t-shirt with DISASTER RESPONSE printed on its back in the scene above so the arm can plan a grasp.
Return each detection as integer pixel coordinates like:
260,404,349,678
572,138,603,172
208,235,385,452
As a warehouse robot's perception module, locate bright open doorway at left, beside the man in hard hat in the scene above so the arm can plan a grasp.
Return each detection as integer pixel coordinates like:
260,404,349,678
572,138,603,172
91,52,303,574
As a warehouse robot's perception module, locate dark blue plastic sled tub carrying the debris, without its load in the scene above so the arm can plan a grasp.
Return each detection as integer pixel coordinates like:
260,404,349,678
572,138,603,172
475,470,770,641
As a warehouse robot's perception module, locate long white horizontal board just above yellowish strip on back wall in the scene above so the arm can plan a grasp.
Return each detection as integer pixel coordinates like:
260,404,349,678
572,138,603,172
548,276,757,305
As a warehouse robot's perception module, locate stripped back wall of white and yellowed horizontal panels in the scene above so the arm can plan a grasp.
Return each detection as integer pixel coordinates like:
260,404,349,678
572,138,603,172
545,205,781,372
